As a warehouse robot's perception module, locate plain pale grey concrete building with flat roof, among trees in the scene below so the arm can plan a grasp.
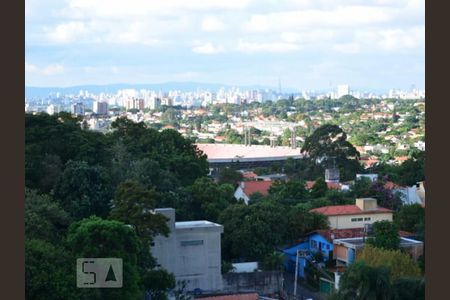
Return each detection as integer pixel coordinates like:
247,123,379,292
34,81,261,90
151,208,223,291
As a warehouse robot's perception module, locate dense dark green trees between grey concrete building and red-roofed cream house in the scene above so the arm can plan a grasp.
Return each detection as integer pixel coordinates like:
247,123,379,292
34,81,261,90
219,199,328,261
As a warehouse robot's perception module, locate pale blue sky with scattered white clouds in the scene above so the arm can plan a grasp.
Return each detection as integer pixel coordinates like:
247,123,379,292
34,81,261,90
25,0,425,90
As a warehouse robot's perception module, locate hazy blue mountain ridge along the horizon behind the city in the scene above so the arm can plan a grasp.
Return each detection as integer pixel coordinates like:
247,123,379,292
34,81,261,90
25,82,299,97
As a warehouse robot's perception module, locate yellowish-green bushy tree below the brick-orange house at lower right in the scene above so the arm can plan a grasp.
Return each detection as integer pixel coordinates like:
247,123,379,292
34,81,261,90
357,245,421,281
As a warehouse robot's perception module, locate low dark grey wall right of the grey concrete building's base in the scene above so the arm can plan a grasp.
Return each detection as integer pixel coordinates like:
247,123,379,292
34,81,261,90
223,271,283,295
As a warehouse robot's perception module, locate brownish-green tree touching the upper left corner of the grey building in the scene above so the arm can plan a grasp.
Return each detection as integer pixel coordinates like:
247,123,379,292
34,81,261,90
111,180,169,241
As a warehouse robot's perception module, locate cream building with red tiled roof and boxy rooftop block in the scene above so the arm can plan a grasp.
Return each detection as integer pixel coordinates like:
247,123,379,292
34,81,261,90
311,198,393,229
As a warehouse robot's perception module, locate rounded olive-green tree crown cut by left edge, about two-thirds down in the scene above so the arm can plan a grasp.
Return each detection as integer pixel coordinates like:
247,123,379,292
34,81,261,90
25,188,71,242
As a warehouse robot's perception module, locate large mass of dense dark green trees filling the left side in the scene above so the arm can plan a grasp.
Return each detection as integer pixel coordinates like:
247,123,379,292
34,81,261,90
25,113,211,299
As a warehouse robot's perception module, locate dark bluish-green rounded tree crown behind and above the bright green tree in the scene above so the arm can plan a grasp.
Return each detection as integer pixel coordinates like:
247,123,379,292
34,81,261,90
55,161,110,220
